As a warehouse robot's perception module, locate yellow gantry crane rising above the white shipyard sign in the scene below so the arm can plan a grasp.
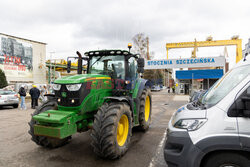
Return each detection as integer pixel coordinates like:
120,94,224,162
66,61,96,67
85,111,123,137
166,36,242,63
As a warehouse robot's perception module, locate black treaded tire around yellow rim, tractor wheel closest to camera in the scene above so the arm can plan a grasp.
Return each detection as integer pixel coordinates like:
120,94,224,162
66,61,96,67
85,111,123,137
91,102,132,159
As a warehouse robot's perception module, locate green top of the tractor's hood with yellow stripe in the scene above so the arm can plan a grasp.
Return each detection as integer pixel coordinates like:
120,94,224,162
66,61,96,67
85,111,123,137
55,74,111,84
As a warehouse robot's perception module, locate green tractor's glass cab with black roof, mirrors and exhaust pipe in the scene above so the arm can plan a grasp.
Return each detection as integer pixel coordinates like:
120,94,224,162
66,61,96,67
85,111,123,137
68,50,144,80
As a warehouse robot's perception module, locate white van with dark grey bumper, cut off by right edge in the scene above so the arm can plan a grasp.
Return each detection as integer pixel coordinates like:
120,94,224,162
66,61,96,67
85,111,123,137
164,56,250,167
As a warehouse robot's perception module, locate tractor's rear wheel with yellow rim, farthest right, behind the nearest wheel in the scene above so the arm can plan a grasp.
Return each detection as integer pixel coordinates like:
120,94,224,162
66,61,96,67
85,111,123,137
139,89,152,131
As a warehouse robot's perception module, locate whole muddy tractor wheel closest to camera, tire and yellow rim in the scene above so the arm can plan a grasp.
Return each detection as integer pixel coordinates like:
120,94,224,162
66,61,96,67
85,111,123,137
91,102,132,159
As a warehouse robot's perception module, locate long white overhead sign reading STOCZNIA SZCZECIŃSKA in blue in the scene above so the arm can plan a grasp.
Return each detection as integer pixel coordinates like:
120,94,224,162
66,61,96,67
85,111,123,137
145,56,225,69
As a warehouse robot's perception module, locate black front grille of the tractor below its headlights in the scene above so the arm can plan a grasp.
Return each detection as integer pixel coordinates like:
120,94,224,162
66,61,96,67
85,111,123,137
55,82,90,107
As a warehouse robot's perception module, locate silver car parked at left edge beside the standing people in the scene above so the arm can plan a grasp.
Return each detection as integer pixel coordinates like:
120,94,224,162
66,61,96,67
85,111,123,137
0,89,19,108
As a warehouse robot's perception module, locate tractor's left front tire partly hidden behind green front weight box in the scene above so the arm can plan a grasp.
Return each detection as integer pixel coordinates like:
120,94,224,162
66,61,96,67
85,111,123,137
28,101,71,148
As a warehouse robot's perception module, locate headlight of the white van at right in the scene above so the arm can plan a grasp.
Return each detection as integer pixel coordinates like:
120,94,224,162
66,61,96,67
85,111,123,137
174,119,207,131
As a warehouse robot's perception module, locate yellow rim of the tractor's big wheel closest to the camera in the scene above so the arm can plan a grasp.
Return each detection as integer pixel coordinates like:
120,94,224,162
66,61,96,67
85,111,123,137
117,114,129,146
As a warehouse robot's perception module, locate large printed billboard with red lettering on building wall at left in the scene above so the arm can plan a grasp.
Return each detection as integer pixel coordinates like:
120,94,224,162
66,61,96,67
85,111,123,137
0,35,33,78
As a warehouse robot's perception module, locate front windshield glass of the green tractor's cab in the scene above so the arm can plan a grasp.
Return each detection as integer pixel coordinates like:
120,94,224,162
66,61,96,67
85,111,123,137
88,55,125,79
